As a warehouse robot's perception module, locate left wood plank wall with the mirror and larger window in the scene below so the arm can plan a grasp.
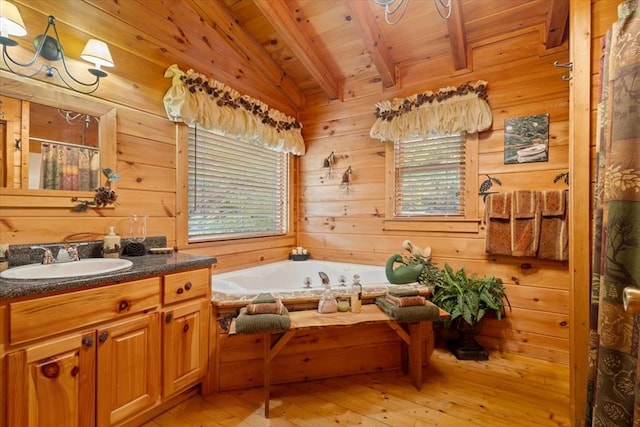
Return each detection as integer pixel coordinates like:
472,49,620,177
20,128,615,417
0,0,295,270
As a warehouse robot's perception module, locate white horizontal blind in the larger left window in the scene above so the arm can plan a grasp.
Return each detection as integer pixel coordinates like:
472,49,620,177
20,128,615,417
188,126,289,241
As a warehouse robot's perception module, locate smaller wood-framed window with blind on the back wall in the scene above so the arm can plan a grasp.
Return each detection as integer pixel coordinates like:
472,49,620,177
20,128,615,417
384,133,480,233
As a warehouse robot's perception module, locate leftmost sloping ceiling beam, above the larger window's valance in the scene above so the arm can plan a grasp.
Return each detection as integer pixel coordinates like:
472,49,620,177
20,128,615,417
186,0,305,109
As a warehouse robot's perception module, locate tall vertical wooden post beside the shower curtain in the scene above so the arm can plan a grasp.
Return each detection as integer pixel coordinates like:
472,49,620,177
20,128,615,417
568,0,594,426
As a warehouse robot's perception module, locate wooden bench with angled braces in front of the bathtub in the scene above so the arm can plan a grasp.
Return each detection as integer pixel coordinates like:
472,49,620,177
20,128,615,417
229,301,449,418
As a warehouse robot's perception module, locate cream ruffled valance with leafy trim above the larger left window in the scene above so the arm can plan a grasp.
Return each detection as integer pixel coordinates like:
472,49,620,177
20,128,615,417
163,64,305,155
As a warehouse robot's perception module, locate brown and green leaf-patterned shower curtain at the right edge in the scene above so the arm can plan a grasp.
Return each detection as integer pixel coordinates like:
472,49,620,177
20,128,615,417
586,0,640,426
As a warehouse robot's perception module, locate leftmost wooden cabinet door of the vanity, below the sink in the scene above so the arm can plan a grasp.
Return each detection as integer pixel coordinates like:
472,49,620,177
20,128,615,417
7,331,96,427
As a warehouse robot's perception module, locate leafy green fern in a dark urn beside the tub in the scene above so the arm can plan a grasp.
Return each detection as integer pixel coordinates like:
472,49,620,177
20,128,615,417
432,264,511,360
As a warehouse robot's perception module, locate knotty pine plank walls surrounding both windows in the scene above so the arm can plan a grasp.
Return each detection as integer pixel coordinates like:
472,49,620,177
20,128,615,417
0,0,617,363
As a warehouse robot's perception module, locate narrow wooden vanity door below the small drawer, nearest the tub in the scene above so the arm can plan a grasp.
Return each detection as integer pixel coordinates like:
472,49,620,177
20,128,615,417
162,300,210,397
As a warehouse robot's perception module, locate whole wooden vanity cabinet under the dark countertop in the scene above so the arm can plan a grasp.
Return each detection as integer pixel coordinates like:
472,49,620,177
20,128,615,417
0,268,210,427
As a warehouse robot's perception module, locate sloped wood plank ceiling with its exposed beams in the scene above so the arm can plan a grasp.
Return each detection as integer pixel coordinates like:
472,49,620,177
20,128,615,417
216,0,569,108
